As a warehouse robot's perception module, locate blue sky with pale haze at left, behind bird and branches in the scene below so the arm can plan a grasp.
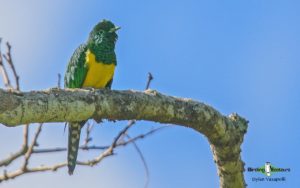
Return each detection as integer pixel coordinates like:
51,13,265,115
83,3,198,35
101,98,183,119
0,0,300,188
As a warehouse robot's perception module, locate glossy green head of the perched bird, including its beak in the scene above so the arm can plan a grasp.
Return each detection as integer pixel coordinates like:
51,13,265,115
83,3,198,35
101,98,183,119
89,20,120,44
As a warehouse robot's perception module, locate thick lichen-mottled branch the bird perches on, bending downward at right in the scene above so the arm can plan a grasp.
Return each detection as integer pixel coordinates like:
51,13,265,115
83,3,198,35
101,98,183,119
0,89,248,188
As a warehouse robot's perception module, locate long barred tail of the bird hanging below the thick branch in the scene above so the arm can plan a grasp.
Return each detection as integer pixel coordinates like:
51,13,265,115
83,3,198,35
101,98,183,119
68,121,86,175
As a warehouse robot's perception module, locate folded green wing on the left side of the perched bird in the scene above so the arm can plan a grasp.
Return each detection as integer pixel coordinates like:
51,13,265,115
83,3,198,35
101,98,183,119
65,44,88,88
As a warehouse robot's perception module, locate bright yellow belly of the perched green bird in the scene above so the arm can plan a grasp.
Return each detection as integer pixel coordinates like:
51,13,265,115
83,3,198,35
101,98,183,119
83,50,115,89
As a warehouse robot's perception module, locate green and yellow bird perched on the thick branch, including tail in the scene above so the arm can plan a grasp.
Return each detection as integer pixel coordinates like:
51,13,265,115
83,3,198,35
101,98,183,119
65,20,119,175
